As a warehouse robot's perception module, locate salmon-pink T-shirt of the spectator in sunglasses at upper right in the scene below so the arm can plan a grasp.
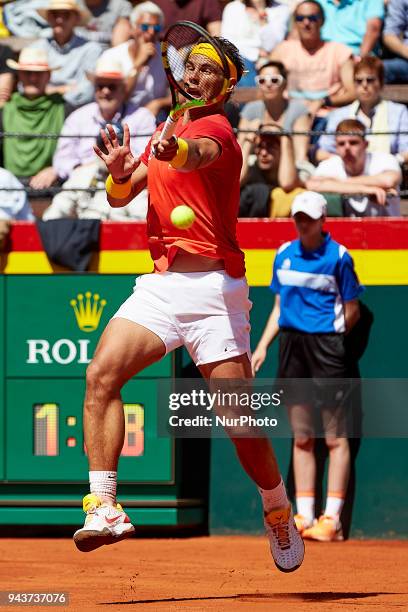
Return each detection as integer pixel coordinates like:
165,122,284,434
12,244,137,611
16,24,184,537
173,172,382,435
276,40,352,100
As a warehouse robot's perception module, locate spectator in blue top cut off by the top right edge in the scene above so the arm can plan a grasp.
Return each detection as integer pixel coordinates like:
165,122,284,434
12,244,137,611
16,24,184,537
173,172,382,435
383,0,408,83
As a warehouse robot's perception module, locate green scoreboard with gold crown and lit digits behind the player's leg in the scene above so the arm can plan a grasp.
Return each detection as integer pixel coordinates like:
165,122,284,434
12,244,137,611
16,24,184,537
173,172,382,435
0,274,206,527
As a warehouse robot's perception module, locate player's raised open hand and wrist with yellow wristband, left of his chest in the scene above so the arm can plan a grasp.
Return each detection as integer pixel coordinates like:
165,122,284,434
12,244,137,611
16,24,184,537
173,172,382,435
94,124,147,208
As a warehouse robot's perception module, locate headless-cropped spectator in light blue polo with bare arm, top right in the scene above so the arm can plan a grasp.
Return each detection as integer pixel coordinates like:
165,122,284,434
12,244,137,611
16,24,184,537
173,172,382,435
319,0,384,57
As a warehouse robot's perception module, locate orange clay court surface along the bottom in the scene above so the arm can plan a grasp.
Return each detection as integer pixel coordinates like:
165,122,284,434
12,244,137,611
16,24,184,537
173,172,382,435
0,536,408,612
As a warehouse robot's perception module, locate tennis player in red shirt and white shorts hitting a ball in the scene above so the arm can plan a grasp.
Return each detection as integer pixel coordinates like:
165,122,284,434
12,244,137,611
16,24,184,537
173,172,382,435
74,39,304,572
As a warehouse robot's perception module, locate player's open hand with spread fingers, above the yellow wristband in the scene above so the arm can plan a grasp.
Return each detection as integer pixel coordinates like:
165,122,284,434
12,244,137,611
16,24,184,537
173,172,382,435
94,123,140,182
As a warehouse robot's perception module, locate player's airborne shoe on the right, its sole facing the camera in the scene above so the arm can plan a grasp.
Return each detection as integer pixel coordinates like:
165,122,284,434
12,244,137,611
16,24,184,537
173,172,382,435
264,505,305,572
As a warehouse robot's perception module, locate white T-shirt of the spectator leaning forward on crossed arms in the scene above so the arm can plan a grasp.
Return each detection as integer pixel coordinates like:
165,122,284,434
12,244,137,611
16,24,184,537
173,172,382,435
314,152,402,217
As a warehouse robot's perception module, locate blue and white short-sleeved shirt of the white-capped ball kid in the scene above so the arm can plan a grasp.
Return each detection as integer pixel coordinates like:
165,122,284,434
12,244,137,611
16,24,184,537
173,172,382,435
270,234,363,334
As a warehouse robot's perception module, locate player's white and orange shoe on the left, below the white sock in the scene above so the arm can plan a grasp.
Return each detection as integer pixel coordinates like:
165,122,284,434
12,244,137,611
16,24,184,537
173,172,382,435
74,493,135,552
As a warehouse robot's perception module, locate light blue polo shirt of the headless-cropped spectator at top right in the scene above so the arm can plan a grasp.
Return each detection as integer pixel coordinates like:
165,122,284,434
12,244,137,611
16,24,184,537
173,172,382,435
319,0,384,55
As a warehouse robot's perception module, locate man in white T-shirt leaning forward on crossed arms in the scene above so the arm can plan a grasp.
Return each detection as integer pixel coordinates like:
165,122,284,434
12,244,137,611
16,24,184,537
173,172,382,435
306,119,402,217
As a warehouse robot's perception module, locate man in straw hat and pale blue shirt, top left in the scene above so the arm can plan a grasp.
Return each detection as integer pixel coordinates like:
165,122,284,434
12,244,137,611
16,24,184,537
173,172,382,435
32,0,102,107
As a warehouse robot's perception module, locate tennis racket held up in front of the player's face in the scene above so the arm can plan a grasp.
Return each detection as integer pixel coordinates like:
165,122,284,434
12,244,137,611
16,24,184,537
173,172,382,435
159,21,230,140
